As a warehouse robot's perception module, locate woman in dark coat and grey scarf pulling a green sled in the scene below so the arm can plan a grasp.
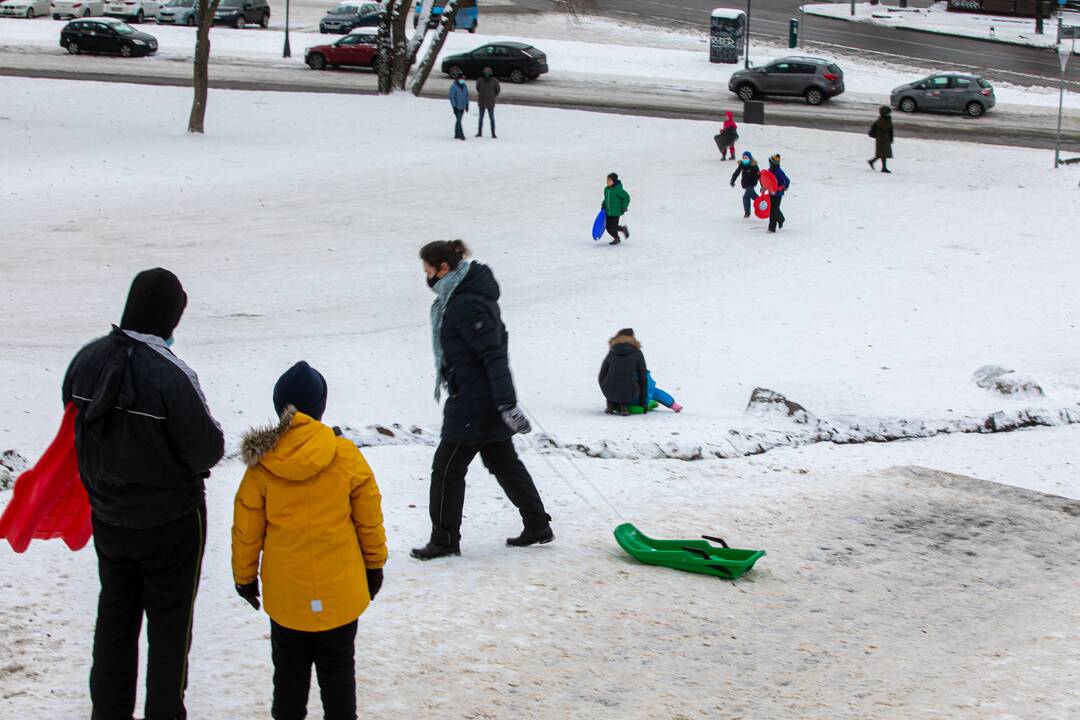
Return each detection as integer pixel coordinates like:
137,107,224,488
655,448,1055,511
411,240,555,560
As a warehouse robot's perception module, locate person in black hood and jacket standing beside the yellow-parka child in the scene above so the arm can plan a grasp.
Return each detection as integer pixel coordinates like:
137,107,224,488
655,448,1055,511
63,268,225,720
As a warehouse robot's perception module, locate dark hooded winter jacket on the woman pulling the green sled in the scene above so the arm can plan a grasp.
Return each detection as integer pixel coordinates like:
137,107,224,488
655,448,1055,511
438,262,517,445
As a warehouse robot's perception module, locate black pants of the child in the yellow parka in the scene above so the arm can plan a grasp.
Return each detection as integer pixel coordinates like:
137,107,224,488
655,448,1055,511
270,620,356,720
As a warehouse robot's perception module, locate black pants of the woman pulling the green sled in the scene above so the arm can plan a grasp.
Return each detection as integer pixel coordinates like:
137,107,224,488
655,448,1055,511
428,439,551,545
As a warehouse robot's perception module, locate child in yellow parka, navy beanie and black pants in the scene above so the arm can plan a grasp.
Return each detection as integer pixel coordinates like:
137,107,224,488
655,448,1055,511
232,362,387,720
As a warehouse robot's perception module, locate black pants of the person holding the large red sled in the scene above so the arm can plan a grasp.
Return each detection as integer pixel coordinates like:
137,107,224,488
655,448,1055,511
90,506,206,720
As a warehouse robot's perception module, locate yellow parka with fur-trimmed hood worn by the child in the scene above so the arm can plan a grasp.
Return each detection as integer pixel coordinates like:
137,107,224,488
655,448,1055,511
232,406,387,633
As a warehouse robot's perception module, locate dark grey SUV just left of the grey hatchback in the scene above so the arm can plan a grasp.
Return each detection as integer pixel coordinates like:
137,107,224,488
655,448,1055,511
728,57,843,105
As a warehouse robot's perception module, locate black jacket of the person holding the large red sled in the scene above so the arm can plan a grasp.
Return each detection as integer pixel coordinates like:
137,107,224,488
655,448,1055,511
63,328,225,529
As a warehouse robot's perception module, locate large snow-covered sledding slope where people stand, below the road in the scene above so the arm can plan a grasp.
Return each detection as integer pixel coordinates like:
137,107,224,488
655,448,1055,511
0,76,1080,720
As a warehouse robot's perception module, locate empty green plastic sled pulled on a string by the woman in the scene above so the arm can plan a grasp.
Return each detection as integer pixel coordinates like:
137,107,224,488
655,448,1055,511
615,522,765,580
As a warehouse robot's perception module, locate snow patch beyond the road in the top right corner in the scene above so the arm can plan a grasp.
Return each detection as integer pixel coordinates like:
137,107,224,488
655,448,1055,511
802,2,1080,53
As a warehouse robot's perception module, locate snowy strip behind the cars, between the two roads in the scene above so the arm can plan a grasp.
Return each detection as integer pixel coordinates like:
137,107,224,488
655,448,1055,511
0,14,1080,109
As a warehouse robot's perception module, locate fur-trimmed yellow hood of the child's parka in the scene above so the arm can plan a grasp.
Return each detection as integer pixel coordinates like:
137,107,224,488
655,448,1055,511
241,405,337,481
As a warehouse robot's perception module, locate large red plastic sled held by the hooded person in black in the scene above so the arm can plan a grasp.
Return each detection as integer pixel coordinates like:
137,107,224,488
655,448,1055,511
0,404,93,553
